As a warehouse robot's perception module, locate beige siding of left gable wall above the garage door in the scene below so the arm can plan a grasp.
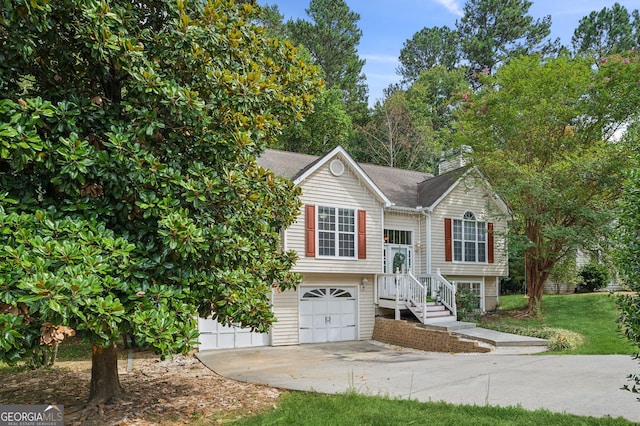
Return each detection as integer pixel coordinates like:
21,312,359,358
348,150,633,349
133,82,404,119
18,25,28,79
285,162,383,274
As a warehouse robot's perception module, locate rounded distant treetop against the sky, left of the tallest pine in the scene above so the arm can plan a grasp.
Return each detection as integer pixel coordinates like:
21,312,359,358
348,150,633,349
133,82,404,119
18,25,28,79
397,26,460,83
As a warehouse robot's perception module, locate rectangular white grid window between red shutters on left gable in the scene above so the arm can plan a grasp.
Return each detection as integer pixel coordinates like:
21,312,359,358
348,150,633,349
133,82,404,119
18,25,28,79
318,206,356,257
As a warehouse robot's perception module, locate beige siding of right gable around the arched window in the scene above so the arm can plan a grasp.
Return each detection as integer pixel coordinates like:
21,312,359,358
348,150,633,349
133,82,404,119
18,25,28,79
431,178,508,276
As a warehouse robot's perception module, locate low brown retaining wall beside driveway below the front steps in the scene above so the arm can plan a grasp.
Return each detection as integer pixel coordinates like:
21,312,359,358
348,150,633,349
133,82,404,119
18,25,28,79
373,317,491,353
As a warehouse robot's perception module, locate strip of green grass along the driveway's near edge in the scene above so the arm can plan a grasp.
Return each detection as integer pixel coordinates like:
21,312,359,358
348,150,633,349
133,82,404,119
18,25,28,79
234,392,633,426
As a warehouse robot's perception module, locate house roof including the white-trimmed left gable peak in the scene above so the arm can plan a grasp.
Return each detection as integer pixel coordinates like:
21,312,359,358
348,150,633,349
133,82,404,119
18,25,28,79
258,146,500,210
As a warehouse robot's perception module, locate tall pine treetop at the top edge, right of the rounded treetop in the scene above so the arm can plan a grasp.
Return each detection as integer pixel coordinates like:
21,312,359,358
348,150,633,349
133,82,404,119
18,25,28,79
456,0,559,76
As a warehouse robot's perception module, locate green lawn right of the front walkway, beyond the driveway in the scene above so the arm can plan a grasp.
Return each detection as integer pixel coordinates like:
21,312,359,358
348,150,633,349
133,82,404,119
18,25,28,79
480,293,637,355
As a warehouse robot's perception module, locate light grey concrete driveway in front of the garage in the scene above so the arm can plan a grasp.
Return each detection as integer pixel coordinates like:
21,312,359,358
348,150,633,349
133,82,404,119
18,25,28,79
196,342,640,423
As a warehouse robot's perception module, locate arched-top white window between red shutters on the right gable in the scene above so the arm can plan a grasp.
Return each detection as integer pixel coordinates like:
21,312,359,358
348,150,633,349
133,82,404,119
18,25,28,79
453,212,487,262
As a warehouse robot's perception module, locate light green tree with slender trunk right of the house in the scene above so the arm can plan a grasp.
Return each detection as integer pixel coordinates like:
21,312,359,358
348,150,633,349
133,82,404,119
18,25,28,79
458,56,640,313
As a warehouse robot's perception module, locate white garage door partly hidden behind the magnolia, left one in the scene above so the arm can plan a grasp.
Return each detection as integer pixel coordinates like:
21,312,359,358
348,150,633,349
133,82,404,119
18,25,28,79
198,318,269,351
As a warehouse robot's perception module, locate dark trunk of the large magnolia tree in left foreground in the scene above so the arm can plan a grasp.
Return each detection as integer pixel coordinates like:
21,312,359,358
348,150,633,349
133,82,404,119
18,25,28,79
89,343,122,405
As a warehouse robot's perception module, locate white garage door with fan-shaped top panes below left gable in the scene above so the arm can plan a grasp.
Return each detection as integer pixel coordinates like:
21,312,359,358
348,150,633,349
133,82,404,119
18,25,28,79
300,287,358,343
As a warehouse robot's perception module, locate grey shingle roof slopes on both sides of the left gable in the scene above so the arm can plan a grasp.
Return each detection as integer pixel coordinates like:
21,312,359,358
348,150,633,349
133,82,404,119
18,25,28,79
258,149,464,208
